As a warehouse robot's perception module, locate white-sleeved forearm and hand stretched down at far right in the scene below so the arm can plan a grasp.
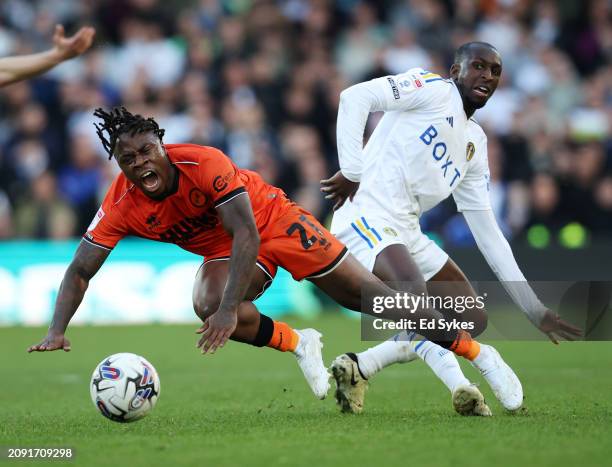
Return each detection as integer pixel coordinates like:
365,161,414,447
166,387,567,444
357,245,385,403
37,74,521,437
463,210,582,344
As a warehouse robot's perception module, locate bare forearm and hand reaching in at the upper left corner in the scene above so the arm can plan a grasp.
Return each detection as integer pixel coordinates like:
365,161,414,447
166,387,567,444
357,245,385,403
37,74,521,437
0,24,96,86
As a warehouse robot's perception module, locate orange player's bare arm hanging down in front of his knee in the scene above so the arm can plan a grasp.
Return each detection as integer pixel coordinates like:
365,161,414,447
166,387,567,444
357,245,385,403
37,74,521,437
198,193,259,353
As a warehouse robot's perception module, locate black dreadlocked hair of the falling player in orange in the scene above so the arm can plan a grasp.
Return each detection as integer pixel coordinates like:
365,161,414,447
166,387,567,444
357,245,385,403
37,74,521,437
94,106,165,159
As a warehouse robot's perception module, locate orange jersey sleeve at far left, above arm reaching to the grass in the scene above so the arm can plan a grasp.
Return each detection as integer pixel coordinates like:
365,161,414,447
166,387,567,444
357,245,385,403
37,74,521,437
83,176,129,250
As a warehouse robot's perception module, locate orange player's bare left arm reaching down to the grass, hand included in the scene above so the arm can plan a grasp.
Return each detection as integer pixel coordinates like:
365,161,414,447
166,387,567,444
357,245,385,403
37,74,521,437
28,240,110,352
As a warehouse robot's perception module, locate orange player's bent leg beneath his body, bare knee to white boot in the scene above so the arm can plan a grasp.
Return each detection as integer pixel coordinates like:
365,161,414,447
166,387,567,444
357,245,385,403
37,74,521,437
193,260,329,399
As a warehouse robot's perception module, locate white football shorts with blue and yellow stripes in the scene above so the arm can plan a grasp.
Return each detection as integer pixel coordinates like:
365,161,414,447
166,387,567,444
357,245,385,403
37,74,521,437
330,208,448,281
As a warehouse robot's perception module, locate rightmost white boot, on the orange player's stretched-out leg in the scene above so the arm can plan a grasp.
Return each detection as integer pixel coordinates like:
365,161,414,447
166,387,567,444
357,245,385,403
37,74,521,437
471,344,523,411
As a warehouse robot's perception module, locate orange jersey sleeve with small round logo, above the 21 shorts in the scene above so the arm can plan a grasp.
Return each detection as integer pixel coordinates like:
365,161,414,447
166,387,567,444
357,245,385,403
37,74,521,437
200,148,246,208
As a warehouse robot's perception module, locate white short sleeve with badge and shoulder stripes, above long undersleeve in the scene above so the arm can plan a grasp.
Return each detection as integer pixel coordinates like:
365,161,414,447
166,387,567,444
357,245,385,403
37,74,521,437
372,68,452,111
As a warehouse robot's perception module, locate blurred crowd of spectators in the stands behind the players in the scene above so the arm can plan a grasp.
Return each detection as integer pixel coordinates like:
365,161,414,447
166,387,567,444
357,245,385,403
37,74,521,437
0,0,612,249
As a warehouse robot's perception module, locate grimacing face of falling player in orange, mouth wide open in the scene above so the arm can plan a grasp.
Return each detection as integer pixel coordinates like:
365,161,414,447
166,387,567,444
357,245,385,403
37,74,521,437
113,131,176,199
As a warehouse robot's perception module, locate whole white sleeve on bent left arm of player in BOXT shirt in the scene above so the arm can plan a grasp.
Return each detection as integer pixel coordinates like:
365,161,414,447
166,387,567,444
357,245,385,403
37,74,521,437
336,68,446,182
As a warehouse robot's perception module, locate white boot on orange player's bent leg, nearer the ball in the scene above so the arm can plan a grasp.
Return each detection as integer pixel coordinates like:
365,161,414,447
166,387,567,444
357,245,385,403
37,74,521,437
294,329,330,399
